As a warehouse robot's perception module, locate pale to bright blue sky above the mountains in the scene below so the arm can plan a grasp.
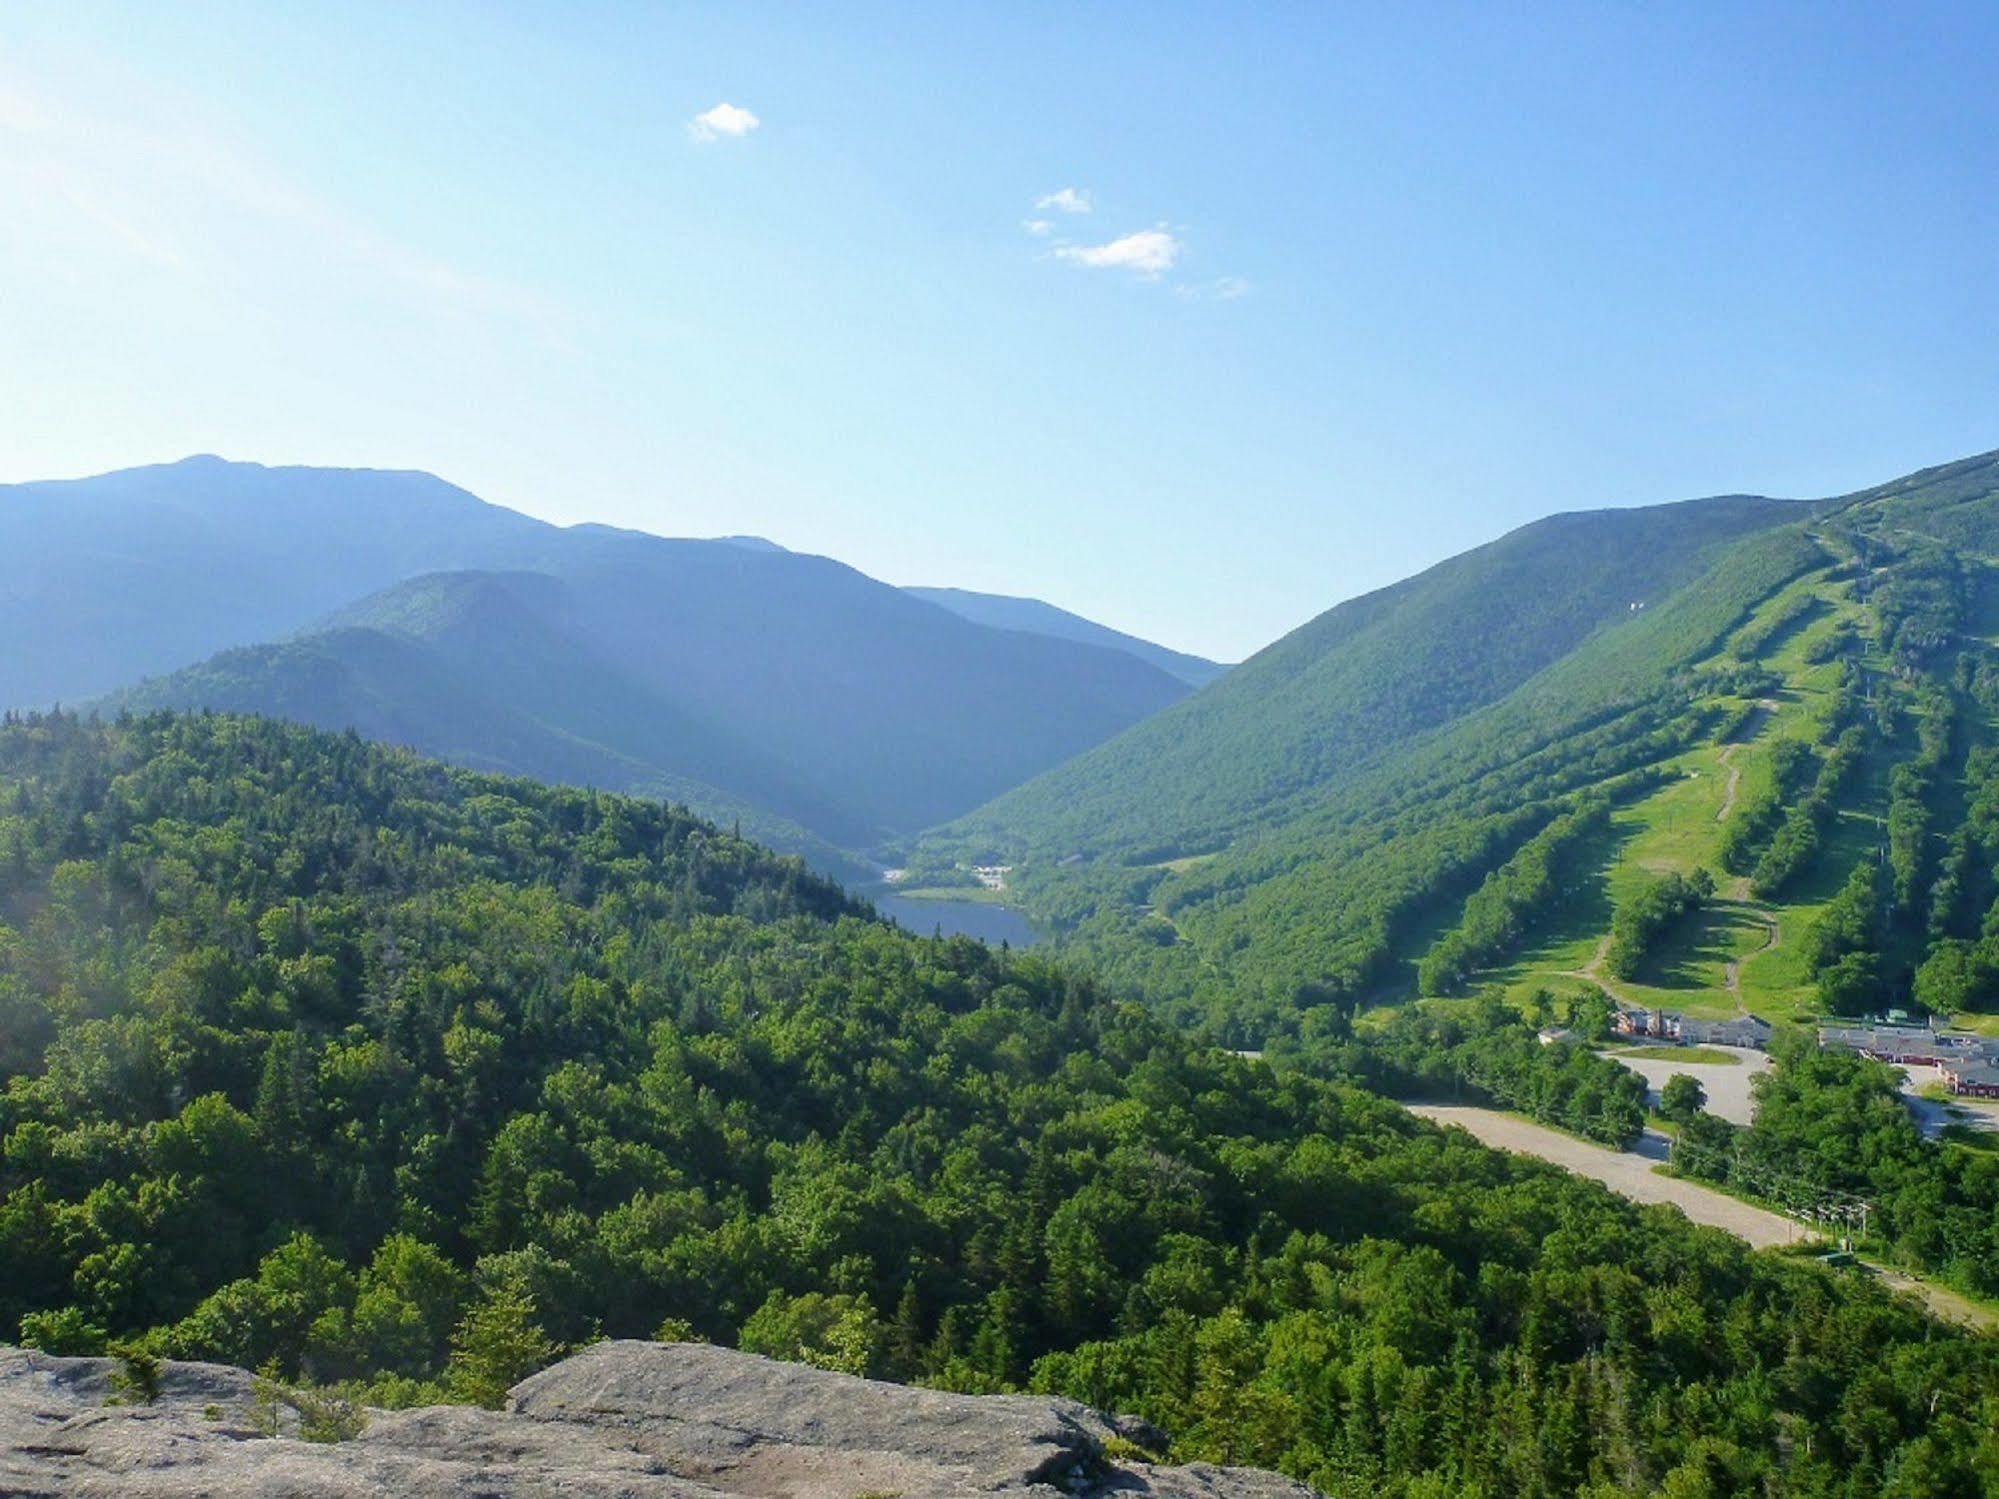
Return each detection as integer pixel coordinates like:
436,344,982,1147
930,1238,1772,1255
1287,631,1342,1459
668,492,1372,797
0,0,1999,658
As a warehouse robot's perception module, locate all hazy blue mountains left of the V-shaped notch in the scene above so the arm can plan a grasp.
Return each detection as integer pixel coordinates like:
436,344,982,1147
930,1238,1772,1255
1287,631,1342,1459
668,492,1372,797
0,458,1187,875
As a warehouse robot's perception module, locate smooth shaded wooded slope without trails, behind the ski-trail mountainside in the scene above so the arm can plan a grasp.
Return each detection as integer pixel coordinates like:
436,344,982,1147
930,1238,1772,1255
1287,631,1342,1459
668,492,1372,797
942,498,1797,861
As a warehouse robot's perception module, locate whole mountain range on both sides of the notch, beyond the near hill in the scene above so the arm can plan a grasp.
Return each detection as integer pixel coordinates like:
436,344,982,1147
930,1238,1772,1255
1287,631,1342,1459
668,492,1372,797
11,454,1999,1045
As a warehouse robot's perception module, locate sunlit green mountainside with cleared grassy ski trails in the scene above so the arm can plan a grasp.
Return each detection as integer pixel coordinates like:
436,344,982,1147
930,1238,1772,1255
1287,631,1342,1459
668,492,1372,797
930,456,1999,1045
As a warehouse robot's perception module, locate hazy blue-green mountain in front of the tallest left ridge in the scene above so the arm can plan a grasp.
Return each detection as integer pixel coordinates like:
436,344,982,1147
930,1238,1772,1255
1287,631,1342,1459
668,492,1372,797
112,551,1185,853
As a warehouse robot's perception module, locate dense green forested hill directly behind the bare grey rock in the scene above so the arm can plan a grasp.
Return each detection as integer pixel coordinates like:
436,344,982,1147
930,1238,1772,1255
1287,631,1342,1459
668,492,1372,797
0,716,1999,1497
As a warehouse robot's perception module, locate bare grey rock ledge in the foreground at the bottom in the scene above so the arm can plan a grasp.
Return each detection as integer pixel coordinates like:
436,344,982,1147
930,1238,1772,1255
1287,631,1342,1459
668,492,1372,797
0,1343,1313,1499
